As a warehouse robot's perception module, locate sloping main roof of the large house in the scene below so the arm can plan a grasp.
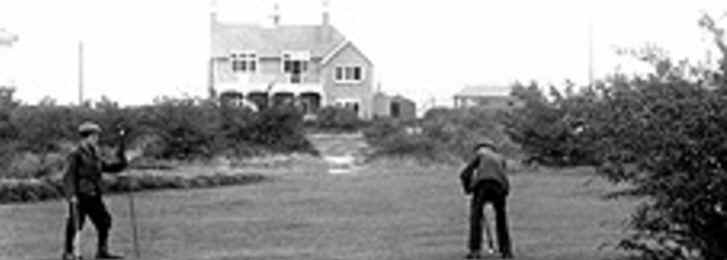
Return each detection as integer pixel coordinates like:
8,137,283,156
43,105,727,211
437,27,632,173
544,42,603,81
211,23,346,58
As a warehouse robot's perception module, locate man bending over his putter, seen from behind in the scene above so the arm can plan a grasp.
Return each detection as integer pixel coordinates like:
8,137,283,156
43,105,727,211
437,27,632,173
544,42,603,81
460,139,512,259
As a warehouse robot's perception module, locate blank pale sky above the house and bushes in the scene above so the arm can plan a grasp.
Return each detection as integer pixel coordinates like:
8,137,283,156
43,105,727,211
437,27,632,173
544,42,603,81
0,0,727,107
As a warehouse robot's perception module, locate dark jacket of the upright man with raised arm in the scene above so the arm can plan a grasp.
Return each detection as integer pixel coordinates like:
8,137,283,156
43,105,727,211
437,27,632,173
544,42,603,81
63,145,127,199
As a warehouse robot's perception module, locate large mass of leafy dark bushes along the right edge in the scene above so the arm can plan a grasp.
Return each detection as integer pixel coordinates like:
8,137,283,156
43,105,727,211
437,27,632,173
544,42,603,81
509,42,727,260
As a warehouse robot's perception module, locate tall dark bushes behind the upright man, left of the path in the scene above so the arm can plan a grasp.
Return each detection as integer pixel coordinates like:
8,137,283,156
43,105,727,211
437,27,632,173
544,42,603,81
0,95,315,177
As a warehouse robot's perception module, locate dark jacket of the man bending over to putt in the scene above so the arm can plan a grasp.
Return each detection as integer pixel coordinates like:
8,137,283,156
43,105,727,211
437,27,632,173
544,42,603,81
459,153,510,195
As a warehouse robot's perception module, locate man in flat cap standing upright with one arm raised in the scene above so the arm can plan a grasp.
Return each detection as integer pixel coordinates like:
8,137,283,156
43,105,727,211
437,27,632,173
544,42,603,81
63,122,127,260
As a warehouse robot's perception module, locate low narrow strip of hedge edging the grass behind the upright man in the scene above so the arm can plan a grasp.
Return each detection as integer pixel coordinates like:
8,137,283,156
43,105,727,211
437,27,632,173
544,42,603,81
0,173,266,204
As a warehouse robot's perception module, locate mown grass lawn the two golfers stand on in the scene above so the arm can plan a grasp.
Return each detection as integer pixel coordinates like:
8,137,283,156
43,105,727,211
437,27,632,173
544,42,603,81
0,161,632,260
